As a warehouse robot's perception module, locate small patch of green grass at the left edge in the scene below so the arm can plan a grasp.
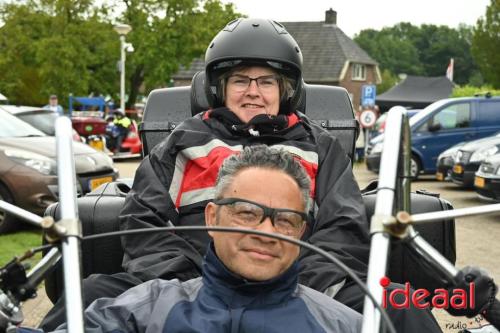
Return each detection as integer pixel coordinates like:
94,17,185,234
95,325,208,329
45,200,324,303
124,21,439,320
0,230,42,267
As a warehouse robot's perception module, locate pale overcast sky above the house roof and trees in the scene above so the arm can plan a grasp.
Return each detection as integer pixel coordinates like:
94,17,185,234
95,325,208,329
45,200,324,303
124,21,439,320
222,0,490,37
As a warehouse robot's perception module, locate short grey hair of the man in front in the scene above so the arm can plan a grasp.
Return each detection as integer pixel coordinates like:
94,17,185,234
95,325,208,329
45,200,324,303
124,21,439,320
215,145,311,212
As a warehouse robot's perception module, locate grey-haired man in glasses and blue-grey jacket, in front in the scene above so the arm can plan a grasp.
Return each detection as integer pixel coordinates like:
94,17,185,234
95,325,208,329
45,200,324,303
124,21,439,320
48,145,361,333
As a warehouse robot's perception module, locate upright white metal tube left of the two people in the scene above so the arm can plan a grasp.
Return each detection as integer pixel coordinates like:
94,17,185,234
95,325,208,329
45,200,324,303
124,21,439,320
56,117,84,333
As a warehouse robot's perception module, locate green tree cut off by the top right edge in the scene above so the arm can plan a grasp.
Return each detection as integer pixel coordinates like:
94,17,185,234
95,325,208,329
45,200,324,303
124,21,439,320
472,0,500,89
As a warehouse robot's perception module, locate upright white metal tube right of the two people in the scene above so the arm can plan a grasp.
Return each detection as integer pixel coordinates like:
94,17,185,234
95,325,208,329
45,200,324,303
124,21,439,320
362,106,410,333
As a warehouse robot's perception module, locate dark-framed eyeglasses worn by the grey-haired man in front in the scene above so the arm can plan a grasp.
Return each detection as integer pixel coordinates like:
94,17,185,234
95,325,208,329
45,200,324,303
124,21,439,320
214,198,309,237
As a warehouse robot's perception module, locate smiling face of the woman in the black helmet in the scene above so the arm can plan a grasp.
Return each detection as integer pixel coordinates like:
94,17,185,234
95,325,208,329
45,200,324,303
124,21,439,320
225,66,280,123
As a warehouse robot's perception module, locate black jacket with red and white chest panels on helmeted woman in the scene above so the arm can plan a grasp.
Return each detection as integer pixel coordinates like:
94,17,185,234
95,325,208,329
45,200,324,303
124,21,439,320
120,109,369,291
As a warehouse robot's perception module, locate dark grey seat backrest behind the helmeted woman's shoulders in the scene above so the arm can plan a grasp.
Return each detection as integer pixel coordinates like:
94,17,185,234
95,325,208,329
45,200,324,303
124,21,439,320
139,72,359,159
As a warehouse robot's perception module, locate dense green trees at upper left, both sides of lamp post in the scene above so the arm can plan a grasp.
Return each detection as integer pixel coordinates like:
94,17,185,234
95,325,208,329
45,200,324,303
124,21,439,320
0,0,237,105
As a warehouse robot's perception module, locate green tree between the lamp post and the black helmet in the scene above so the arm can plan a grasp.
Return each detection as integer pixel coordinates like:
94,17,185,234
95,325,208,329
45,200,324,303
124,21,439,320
114,0,237,106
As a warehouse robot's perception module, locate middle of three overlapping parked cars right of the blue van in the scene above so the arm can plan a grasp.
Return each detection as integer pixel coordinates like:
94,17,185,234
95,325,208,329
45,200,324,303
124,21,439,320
451,132,500,188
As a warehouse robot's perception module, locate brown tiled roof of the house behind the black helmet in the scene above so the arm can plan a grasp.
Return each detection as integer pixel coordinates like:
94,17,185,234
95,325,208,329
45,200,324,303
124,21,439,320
174,22,377,82
